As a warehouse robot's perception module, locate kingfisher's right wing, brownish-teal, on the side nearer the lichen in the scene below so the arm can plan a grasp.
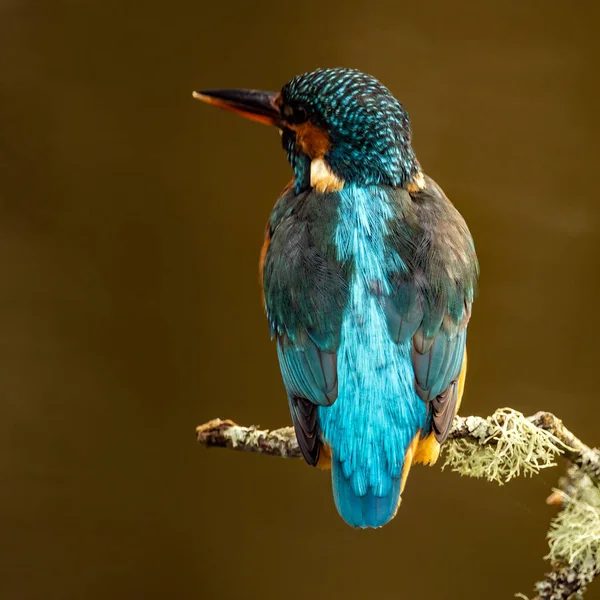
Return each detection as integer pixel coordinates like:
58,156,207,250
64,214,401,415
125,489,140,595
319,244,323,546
386,177,478,443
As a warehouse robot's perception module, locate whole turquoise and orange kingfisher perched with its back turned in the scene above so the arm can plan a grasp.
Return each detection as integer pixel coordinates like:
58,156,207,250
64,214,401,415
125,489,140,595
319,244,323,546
193,68,479,528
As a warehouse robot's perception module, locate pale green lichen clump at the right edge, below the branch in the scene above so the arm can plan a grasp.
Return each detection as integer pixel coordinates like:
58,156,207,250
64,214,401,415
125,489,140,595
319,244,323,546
546,475,600,575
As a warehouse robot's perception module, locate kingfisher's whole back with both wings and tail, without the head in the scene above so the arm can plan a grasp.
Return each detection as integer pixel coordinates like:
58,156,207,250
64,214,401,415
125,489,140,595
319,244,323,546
264,178,477,527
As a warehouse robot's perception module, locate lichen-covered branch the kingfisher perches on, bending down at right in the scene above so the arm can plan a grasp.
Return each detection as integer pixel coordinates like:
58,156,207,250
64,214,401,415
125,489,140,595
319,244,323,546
196,409,600,600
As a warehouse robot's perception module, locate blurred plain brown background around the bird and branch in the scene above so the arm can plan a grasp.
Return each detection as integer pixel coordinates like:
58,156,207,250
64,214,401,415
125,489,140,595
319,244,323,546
0,0,600,600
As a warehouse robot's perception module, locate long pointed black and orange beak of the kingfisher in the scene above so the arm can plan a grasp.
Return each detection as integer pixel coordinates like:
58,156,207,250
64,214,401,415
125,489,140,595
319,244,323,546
192,90,281,126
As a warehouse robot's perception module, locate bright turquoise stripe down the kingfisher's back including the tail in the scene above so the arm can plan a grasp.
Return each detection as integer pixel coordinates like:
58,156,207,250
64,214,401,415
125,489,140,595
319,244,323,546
319,185,427,527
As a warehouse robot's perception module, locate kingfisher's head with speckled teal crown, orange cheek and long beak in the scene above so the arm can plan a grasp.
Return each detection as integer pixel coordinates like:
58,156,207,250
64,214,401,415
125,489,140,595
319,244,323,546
194,69,419,192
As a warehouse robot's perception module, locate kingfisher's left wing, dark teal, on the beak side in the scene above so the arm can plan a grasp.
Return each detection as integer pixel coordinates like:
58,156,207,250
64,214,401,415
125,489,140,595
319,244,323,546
261,189,347,464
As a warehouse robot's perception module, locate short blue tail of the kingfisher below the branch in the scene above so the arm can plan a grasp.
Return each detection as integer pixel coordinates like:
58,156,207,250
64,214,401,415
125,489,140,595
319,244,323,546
331,459,401,529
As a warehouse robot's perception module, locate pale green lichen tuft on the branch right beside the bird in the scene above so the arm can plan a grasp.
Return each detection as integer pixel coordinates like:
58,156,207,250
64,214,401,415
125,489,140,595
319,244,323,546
442,408,563,485
